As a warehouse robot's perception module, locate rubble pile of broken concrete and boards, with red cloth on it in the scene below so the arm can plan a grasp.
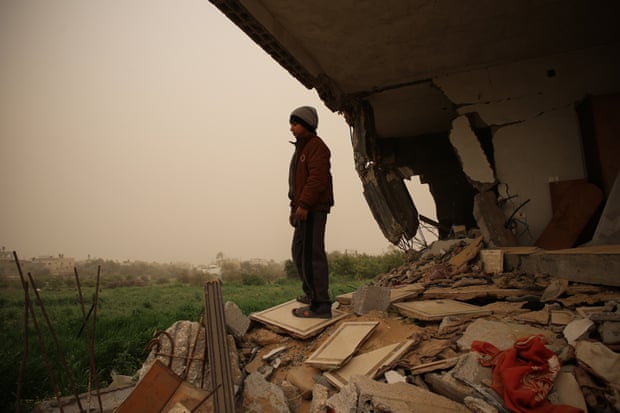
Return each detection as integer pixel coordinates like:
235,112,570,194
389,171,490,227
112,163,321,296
77,237,620,413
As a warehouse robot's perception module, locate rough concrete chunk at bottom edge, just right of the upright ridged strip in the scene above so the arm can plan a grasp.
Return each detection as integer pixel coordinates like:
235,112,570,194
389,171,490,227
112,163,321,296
243,373,290,413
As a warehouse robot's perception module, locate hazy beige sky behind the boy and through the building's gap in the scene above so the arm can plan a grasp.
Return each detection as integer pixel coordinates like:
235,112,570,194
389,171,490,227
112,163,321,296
0,0,434,264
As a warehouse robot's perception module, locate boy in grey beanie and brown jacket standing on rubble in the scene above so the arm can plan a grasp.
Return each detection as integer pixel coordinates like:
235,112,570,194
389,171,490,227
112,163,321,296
288,106,334,318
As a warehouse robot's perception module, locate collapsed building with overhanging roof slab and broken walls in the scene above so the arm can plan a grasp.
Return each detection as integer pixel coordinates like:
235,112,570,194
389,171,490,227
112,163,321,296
211,0,620,249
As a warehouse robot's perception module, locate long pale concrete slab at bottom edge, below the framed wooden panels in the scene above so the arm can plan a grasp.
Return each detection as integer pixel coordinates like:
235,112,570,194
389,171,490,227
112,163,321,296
327,376,467,413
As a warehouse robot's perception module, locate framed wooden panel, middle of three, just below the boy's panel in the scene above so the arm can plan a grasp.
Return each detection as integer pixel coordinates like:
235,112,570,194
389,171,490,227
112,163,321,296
304,321,379,370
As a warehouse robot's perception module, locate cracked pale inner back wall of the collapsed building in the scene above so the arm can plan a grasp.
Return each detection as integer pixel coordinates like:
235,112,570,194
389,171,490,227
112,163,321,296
433,45,620,244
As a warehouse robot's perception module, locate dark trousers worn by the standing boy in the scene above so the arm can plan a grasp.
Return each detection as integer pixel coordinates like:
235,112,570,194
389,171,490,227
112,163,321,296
291,212,331,309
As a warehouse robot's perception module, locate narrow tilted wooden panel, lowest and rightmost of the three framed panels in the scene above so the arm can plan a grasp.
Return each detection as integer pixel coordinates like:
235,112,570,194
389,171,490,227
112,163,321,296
323,340,414,389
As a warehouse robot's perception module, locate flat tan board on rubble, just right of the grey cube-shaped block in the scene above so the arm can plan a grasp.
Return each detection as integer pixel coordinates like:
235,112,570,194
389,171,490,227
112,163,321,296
393,300,492,321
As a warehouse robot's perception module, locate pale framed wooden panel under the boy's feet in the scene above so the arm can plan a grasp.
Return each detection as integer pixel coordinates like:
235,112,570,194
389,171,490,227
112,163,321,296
249,300,348,339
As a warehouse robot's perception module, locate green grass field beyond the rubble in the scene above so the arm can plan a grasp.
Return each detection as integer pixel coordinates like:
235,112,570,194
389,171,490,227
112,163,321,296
0,277,367,412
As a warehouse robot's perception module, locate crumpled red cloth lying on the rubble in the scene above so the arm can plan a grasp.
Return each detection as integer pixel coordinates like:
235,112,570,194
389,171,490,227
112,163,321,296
471,336,583,413
